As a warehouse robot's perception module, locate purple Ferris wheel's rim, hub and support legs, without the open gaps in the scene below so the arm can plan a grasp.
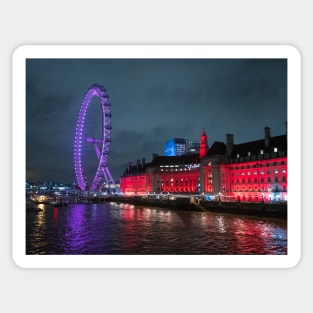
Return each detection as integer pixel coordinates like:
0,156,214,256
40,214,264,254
74,84,113,190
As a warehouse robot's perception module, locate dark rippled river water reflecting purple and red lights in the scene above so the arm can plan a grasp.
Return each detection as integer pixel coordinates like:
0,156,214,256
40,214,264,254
26,203,287,255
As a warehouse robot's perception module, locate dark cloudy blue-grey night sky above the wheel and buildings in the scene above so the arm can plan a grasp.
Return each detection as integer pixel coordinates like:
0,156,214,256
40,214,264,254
26,59,287,183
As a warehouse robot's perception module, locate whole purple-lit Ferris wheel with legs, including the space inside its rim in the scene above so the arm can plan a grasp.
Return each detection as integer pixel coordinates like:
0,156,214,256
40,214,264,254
74,84,114,191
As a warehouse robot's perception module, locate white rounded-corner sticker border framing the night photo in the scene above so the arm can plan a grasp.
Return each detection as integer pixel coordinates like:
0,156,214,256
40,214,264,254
12,45,301,268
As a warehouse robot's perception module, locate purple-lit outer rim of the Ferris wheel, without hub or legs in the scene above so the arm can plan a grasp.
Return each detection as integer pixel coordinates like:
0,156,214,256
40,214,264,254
74,84,112,191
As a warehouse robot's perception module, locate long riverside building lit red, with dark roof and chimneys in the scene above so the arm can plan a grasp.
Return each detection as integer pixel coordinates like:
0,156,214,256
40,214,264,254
120,127,288,202
